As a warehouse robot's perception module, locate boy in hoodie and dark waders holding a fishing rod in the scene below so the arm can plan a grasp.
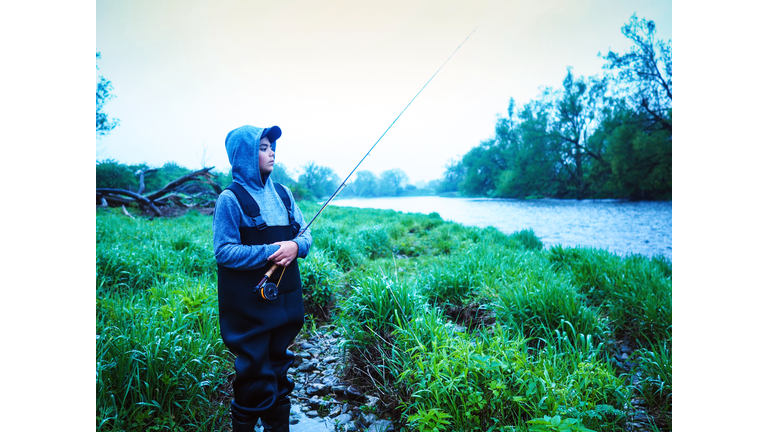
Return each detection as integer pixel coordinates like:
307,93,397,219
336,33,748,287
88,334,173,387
213,126,312,432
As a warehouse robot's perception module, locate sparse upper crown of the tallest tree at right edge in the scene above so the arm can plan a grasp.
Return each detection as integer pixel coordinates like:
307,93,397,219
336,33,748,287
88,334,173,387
603,14,672,131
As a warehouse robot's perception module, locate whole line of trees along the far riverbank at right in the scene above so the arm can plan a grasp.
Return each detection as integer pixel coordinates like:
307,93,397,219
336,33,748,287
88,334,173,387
438,15,672,200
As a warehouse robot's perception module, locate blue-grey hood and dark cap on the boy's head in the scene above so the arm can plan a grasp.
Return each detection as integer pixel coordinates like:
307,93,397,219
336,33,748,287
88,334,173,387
224,126,282,190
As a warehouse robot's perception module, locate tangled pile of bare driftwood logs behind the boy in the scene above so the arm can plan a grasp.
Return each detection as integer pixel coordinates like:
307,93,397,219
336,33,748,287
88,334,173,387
96,167,222,216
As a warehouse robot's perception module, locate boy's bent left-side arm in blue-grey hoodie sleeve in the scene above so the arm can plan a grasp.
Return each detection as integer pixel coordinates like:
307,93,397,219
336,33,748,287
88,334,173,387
213,192,280,270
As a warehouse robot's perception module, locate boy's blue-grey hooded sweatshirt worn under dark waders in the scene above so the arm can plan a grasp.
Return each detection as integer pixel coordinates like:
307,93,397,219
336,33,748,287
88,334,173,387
213,126,312,270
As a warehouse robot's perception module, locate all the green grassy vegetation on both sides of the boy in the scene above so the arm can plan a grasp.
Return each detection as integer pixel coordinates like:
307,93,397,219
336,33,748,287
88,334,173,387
96,201,672,431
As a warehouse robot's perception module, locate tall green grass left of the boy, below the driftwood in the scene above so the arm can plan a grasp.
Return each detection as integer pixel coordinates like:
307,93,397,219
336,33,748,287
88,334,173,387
96,212,231,431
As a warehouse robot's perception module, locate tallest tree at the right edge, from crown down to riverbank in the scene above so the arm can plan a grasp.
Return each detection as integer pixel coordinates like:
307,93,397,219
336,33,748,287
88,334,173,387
600,15,672,199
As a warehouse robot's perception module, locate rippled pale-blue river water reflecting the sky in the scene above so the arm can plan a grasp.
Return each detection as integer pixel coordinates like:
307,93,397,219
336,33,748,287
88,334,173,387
332,197,672,259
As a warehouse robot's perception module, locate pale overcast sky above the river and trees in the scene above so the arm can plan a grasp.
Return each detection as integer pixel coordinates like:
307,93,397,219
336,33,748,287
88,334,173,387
95,0,672,183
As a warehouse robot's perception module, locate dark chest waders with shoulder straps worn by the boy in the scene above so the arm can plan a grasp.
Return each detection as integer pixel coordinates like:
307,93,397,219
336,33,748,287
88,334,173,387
218,183,304,431
